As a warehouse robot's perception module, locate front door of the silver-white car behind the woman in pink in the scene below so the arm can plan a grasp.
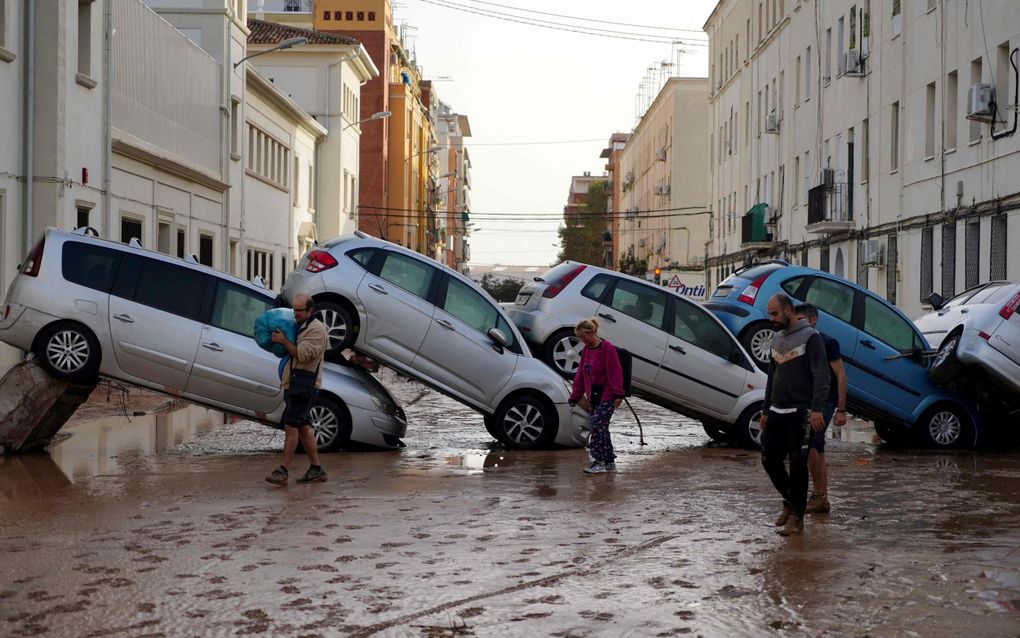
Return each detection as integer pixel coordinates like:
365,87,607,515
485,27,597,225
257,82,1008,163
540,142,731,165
655,297,748,416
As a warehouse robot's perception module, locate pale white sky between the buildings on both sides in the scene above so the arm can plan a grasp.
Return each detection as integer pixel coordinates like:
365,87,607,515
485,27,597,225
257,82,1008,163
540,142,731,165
394,0,716,265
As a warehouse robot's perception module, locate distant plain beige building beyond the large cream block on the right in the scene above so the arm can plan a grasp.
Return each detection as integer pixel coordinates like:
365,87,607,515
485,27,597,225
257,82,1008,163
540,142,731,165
617,78,712,297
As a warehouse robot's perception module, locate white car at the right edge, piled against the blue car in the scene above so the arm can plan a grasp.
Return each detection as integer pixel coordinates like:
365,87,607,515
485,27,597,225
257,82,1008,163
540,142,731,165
914,282,1020,406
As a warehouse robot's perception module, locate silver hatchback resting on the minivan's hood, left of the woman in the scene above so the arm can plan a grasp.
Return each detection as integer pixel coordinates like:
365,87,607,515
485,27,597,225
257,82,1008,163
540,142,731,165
283,233,590,449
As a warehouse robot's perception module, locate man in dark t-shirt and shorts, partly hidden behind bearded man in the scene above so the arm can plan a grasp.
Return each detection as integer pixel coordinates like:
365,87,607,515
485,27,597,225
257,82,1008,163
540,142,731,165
794,303,847,513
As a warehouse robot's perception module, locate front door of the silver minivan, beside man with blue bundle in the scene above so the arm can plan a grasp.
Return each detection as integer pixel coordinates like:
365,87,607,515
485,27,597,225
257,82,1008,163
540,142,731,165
187,280,284,415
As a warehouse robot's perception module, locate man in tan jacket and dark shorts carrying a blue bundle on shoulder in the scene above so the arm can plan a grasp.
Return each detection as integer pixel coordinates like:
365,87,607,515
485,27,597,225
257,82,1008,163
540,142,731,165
265,295,329,485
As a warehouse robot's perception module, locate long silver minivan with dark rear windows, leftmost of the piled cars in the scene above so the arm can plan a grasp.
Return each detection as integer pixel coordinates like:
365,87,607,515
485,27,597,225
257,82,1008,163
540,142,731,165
0,229,407,451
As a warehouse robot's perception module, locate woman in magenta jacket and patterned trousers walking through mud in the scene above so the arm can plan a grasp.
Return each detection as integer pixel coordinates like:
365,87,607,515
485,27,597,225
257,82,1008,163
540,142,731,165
569,318,624,474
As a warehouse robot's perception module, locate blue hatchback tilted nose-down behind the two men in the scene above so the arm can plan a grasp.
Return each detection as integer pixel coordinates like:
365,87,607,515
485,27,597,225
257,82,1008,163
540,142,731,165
705,261,982,448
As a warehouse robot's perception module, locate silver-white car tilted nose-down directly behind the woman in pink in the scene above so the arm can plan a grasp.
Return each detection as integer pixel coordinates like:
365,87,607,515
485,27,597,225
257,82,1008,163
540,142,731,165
510,261,766,446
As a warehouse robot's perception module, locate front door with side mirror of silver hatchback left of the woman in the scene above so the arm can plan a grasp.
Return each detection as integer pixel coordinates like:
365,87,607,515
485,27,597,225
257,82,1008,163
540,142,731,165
413,275,520,408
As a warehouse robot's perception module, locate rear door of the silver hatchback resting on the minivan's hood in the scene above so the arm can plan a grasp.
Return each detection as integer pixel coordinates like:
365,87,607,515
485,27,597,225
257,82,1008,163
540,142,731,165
358,250,440,365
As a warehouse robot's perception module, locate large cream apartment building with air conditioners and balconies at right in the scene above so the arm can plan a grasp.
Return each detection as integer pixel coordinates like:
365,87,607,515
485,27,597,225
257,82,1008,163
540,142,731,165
705,0,1020,317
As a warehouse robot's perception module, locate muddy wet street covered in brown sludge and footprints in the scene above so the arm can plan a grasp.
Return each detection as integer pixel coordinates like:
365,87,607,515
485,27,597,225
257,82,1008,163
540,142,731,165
0,377,1020,637
